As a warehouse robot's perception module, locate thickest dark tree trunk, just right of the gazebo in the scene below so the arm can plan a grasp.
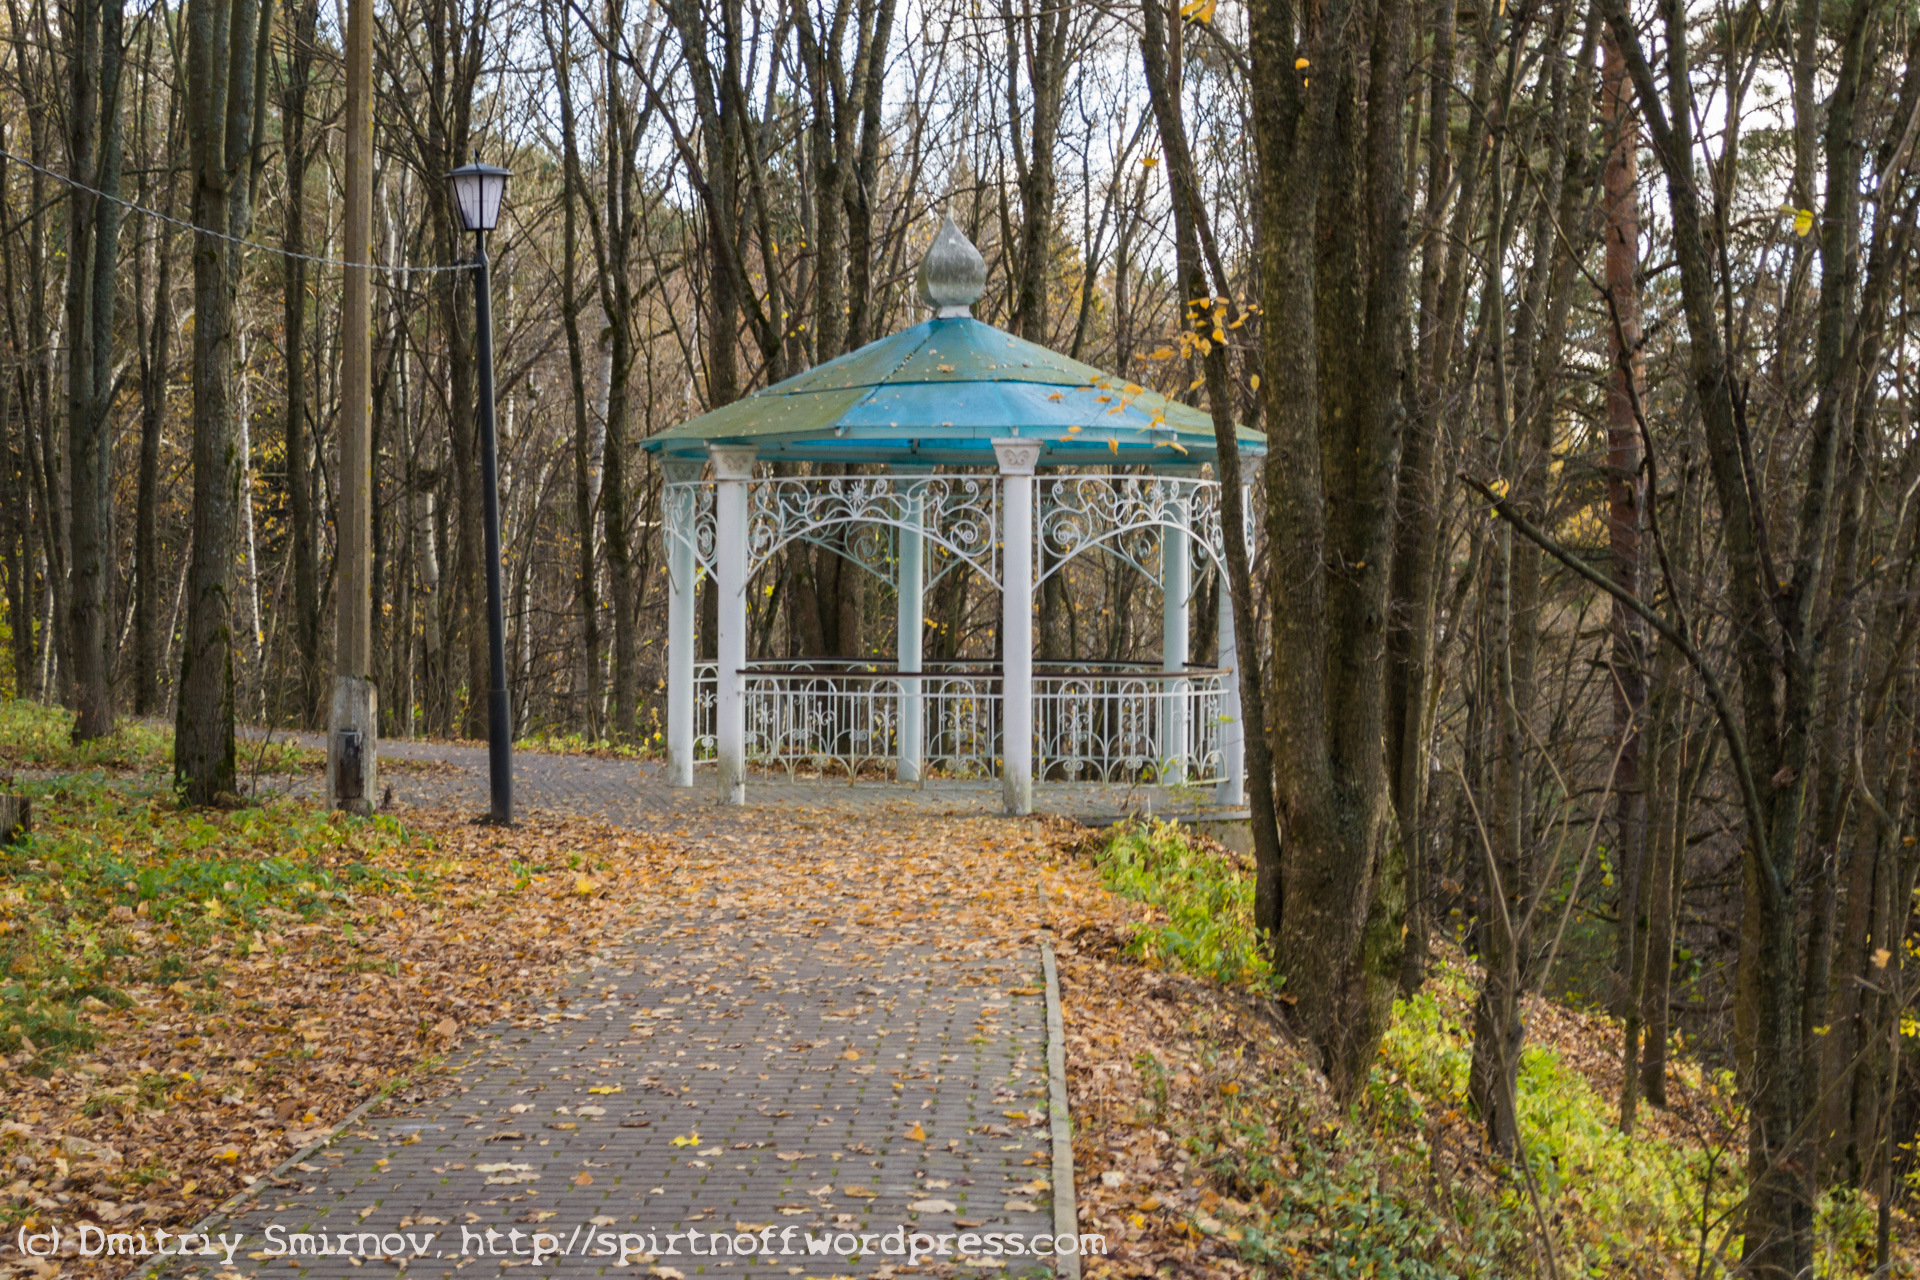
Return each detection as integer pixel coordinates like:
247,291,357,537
1248,0,1409,1098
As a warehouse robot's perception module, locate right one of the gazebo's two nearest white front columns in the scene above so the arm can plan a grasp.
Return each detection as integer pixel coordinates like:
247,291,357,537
993,439,1041,816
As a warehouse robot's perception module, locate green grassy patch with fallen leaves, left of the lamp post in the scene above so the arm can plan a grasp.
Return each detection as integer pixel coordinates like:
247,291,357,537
0,720,432,1071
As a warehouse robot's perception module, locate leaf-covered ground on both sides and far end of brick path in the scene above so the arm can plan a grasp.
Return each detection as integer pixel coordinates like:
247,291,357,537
0,710,1907,1280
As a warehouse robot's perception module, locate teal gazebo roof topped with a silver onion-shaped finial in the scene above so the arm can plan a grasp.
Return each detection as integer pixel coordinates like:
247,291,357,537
641,221,1267,466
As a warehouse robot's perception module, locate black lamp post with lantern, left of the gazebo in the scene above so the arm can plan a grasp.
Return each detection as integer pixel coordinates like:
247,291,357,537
447,161,513,825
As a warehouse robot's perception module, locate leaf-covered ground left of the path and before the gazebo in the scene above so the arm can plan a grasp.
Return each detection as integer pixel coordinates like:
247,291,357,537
0,721,1106,1274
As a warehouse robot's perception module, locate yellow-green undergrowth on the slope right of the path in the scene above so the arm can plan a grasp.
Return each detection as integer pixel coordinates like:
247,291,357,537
1092,821,1872,1280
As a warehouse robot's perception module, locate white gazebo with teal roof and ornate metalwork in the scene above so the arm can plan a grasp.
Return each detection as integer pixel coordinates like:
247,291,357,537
645,219,1265,814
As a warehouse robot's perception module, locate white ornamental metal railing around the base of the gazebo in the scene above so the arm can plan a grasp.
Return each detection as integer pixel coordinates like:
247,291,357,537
693,660,1227,783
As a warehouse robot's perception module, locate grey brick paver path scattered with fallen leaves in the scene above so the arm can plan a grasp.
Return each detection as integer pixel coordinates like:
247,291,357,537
169,745,1075,1280
